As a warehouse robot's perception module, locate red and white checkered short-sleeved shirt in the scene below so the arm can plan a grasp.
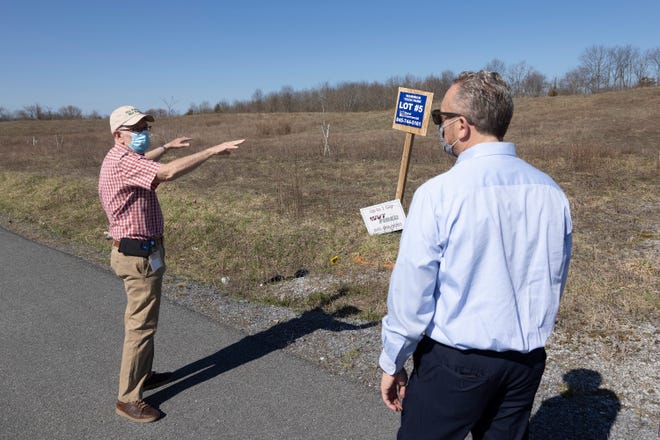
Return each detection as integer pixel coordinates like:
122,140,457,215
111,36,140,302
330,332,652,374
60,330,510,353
99,144,164,240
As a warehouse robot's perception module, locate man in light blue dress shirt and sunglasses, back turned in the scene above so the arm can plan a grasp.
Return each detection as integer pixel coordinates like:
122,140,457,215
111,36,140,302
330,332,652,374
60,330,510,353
379,71,572,440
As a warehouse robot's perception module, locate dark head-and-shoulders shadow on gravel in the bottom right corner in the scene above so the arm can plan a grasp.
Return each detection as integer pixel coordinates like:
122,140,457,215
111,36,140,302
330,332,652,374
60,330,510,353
529,369,621,440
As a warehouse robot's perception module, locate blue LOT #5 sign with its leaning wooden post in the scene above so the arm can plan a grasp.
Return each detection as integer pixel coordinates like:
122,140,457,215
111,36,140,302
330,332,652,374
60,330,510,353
392,87,433,200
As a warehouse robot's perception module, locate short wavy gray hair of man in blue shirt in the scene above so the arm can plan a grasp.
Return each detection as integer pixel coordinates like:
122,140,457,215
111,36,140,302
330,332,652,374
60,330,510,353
454,70,513,140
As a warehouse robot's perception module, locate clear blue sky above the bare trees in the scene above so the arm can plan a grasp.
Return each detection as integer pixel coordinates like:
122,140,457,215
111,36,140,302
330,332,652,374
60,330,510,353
0,0,660,115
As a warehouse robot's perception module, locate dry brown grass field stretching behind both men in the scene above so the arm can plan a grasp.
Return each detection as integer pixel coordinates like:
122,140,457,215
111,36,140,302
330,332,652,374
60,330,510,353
0,88,660,336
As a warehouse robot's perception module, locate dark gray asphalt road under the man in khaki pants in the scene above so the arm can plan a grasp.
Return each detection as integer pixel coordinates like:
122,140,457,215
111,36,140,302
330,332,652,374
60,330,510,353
0,228,399,440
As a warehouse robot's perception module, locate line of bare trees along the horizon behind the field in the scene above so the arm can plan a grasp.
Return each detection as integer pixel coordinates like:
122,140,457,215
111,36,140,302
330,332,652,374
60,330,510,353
0,45,660,121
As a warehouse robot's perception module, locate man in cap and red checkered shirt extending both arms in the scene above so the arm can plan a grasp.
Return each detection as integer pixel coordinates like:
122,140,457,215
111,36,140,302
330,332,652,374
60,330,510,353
99,105,244,422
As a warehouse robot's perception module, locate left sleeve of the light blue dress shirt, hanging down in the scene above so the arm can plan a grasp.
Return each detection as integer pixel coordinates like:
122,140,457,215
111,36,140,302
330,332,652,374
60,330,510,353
379,188,441,374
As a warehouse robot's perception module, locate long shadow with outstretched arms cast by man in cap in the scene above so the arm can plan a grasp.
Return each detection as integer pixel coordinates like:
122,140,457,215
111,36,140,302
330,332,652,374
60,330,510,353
144,290,377,407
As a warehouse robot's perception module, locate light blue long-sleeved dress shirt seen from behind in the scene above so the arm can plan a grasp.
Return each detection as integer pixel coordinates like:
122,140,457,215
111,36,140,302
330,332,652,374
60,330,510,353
379,142,572,374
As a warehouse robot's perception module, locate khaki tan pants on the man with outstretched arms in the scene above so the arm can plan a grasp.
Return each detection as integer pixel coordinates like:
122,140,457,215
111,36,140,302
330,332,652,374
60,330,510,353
110,243,165,402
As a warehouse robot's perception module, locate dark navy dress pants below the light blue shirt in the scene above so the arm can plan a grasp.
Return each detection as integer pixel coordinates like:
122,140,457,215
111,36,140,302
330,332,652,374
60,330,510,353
397,337,546,440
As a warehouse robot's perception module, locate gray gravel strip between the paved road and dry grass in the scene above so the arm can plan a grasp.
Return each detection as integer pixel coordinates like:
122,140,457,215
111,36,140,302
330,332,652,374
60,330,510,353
164,276,660,440
